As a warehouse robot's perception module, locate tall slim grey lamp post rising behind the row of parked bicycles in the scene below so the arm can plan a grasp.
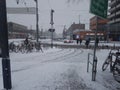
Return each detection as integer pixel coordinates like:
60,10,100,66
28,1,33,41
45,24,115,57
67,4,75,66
34,0,39,42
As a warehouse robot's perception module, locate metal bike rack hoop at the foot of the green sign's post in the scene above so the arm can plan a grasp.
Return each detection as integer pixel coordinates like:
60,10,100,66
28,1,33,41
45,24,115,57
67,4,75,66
87,53,97,81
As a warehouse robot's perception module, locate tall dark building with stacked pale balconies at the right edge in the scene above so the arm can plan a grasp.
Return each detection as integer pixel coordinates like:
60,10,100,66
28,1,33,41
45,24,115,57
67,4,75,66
108,0,120,41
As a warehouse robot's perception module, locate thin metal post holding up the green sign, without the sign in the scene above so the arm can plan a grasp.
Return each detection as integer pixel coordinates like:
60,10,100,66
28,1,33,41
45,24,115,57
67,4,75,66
92,16,98,81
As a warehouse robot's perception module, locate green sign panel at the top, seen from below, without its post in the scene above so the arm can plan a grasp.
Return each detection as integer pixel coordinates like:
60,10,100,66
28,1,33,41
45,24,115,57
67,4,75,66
90,0,108,18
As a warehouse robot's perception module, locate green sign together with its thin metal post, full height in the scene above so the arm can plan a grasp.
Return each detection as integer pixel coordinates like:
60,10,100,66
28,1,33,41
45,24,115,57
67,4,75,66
90,0,108,81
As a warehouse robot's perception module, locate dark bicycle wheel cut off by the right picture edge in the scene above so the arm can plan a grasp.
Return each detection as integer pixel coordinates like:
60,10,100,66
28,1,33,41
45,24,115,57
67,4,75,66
113,64,120,83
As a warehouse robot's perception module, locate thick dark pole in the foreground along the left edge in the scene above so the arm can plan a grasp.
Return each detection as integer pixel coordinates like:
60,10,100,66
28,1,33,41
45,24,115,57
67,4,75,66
0,0,12,90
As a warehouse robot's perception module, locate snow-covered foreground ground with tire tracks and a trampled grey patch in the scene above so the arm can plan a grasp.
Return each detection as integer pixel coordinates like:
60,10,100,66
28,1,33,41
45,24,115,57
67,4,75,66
0,48,120,90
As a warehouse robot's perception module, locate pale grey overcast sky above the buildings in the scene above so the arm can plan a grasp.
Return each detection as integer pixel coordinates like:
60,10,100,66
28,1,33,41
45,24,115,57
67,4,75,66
6,0,92,33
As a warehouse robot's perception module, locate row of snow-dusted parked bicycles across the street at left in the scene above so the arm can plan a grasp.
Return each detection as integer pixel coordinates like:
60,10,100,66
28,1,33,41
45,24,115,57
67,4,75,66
9,40,43,53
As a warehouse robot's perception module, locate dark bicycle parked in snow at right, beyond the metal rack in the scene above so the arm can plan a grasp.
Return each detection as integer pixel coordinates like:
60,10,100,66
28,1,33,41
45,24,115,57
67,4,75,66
102,50,120,83
